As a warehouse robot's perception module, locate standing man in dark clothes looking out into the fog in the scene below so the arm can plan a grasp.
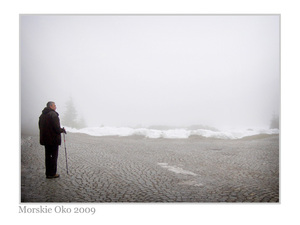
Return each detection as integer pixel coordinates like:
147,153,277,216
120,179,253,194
39,102,66,178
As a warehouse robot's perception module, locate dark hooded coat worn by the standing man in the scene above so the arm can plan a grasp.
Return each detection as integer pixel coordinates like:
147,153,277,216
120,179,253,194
39,107,63,145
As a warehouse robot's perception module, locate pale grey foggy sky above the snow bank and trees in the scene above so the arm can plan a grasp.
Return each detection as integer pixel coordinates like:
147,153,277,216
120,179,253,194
20,15,280,132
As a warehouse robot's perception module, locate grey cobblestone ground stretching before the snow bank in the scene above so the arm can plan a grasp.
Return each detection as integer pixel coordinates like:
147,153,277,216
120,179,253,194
21,133,279,202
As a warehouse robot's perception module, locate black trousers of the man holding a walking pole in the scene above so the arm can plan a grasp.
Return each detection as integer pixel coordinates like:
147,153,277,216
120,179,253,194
45,145,58,176
